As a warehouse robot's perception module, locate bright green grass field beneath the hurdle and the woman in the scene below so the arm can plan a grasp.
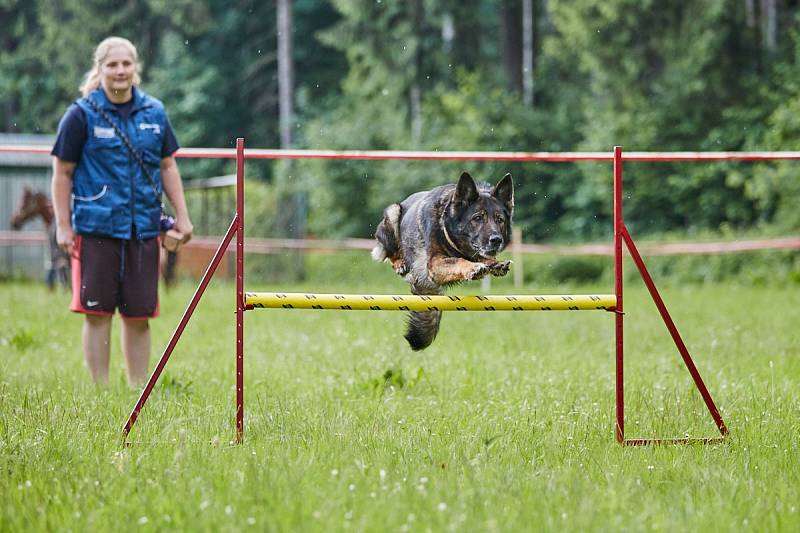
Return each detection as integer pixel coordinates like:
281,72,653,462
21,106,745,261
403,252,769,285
0,256,800,531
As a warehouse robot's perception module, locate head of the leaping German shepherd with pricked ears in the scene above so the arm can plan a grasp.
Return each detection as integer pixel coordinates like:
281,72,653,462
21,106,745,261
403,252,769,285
444,172,514,259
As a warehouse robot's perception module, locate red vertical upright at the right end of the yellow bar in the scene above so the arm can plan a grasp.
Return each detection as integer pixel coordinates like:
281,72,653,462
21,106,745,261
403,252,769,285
614,146,625,443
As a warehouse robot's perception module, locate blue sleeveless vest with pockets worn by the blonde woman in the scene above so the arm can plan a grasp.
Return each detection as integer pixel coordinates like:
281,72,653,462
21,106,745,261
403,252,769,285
72,87,167,240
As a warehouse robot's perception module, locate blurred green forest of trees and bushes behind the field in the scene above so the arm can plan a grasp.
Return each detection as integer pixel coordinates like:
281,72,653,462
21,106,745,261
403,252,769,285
0,0,800,242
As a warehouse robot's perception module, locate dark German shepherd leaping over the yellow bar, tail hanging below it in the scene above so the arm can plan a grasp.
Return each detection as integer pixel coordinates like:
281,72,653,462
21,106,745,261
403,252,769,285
372,172,514,351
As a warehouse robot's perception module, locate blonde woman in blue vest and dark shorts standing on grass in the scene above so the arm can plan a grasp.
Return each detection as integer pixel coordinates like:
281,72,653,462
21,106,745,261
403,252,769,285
51,37,192,387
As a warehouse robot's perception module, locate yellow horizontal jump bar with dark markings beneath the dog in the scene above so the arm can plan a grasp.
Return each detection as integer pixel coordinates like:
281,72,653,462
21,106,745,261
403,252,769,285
245,292,617,311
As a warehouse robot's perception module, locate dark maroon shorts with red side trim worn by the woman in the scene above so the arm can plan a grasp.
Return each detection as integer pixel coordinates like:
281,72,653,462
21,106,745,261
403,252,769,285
70,235,159,319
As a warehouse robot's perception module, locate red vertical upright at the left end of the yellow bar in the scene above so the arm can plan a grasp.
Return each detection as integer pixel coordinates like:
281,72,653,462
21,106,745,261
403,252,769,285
236,137,244,443
